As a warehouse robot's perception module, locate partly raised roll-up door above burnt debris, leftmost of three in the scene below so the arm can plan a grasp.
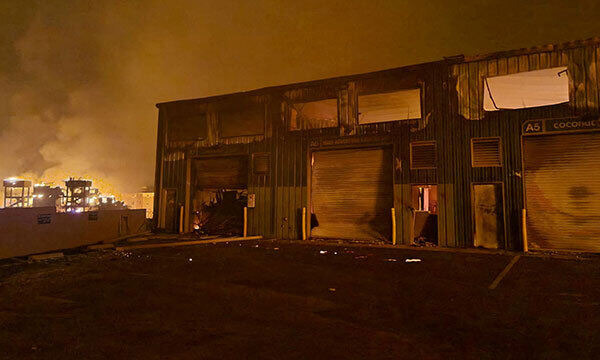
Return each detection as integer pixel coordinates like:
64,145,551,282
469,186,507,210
194,156,248,189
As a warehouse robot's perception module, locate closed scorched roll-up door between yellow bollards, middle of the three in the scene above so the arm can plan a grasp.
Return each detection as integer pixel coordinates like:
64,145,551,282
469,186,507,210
311,148,394,240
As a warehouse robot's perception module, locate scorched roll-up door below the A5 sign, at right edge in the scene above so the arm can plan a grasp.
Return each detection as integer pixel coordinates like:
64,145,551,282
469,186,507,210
523,133,600,251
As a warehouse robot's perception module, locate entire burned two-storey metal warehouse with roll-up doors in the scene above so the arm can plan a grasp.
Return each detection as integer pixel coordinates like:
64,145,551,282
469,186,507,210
154,39,600,252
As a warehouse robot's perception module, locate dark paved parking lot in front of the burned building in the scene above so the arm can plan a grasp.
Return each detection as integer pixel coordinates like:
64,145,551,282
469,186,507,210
0,240,600,359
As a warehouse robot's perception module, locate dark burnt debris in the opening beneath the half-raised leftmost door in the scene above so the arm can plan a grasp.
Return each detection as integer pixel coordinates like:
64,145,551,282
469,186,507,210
196,190,248,236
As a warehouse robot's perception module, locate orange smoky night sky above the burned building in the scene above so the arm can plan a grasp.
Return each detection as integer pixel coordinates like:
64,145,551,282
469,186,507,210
0,0,600,192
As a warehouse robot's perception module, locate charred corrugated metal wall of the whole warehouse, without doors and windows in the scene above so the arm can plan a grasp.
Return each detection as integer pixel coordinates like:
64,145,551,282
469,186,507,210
157,40,600,250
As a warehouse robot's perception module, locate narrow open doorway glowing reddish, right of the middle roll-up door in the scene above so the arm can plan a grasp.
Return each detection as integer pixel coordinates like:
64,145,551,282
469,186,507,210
411,185,438,246
